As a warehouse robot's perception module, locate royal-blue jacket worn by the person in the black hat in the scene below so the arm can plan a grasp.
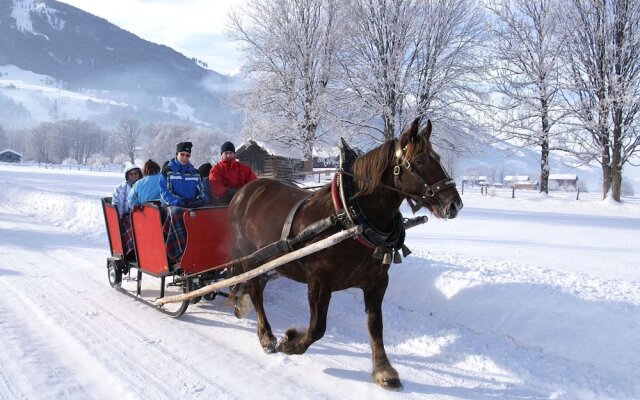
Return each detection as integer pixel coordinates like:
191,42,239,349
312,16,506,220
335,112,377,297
160,158,209,206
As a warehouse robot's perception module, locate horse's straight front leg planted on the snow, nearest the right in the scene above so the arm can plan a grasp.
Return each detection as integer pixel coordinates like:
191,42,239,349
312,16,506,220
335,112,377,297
363,274,402,390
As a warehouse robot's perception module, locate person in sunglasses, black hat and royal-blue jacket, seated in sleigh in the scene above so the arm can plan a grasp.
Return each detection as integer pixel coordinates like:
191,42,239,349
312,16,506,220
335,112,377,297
160,142,209,262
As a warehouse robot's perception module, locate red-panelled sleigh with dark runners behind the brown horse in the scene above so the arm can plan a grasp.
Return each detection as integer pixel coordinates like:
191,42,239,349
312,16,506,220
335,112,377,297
102,197,232,317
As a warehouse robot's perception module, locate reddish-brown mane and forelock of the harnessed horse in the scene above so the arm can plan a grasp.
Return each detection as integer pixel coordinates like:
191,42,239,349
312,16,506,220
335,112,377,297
353,134,431,197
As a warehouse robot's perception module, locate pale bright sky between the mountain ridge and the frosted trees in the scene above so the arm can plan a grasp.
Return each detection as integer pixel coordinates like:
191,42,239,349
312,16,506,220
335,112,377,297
57,0,244,74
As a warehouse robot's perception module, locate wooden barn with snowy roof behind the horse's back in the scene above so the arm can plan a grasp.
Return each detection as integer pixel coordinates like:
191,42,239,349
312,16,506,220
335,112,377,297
236,140,304,179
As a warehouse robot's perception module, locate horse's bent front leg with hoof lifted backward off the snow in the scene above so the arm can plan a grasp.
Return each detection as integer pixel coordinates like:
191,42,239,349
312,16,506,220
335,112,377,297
278,280,331,354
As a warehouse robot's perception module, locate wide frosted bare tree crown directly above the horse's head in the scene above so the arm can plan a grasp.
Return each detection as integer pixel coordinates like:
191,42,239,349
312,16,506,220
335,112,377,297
340,0,483,141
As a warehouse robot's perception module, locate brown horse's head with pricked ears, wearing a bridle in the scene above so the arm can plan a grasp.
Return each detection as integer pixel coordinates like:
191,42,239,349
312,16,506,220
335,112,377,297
393,118,462,219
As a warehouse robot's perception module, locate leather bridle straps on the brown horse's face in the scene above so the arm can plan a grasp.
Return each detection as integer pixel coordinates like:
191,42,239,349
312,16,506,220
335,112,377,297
385,145,456,213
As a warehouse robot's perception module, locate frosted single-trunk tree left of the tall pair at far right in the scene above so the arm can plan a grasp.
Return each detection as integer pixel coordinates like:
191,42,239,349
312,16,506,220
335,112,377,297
488,0,565,193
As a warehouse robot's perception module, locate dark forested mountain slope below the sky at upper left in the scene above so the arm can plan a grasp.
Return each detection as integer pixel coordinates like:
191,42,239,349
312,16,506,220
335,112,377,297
0,0,240,128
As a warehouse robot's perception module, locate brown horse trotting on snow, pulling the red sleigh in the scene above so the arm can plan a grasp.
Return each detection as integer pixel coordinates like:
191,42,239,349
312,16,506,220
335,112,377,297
229,119,462,389
